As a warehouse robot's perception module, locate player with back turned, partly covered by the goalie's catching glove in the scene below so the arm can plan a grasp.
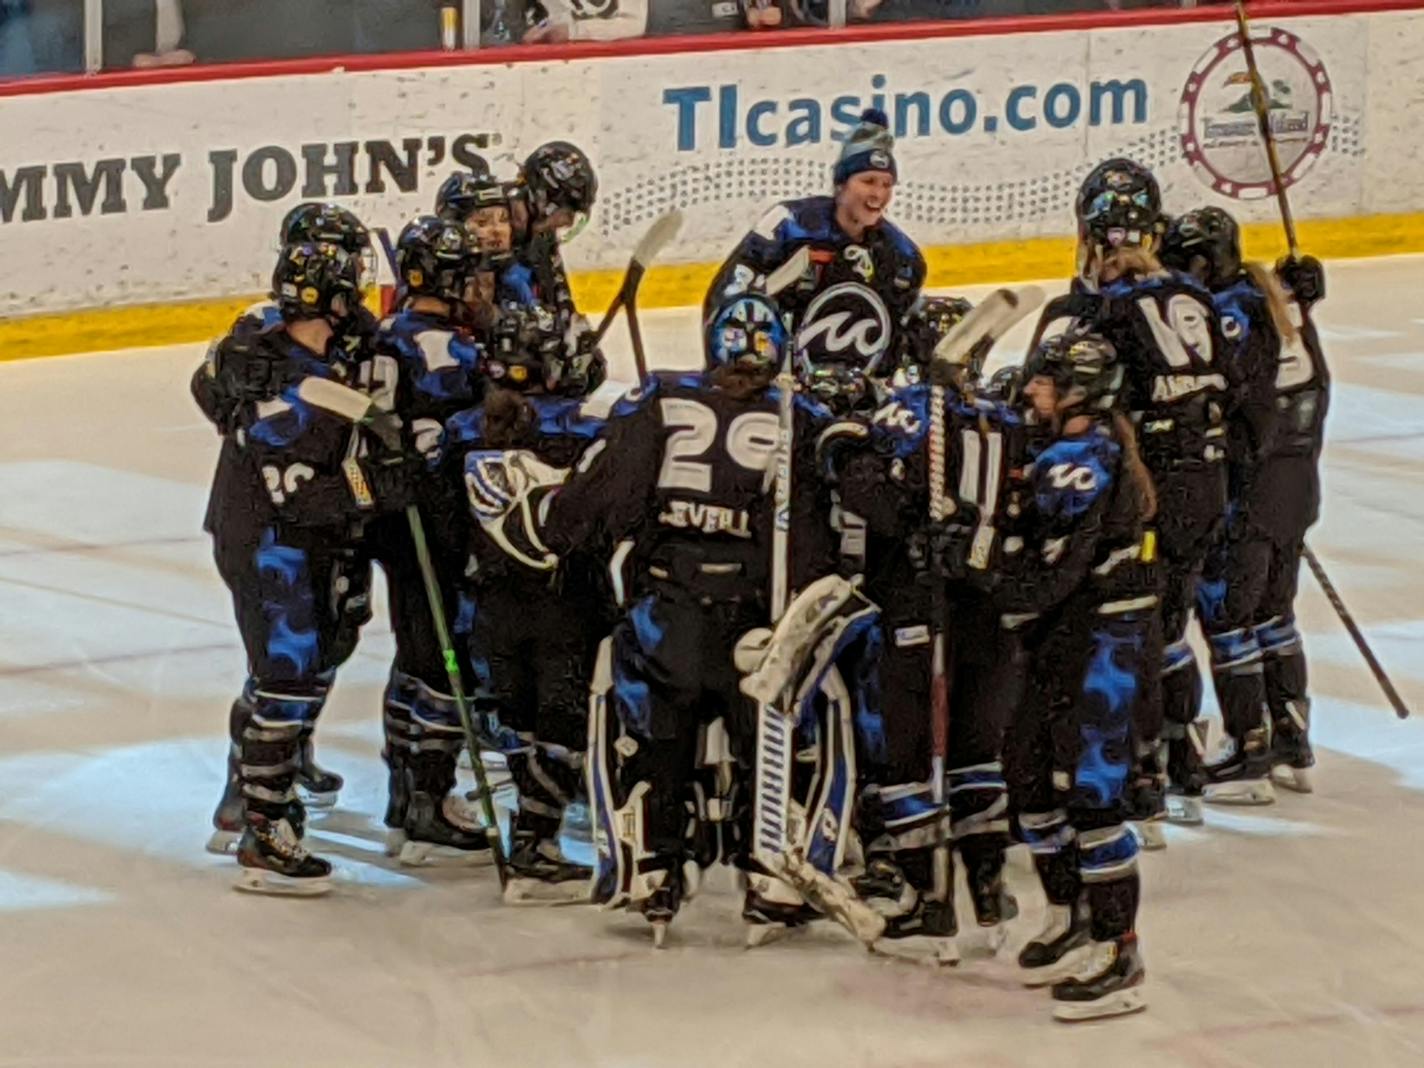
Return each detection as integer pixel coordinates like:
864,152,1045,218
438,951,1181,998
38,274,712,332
443,306,607,904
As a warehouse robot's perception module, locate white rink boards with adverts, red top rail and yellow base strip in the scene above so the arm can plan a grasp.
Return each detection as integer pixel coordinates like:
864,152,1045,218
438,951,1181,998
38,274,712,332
0,3,1424,359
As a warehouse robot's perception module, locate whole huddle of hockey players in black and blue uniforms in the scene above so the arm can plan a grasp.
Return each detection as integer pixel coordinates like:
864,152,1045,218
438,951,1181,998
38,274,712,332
192,111,1329,1020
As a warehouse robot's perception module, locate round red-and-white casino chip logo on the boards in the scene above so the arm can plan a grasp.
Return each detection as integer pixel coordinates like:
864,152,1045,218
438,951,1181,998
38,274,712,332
1178,26,1334,201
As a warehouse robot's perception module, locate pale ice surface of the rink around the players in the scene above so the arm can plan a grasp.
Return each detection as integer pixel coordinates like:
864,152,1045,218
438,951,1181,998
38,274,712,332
0,256,1424,1068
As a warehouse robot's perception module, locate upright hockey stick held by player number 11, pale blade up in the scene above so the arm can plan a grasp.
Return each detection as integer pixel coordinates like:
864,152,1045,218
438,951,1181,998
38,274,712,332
928,286,1044,901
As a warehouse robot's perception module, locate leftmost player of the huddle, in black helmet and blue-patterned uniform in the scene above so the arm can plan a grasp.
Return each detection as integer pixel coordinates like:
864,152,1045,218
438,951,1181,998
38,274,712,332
206,242,410,894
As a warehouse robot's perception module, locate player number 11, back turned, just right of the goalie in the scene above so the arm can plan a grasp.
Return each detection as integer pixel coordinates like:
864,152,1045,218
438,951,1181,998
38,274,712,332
822,305,1021,961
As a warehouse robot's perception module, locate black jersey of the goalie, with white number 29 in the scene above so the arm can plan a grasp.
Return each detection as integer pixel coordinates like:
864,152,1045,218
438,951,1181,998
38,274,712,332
544,373,830,600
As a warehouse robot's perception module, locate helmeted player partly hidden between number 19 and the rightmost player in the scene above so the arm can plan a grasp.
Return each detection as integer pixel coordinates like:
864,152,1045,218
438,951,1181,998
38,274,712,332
1162,208,1294,803
